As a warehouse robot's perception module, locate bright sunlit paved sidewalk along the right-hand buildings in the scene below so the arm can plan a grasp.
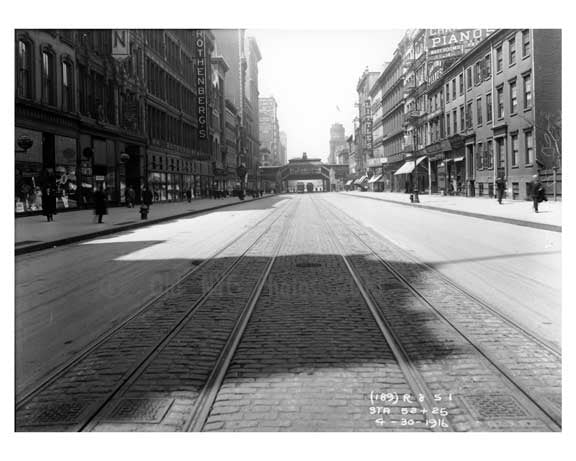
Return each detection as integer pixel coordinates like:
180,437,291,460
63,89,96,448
344,192,562,232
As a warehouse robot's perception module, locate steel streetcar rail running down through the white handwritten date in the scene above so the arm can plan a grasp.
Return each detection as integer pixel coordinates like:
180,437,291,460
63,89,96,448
313,200,452,432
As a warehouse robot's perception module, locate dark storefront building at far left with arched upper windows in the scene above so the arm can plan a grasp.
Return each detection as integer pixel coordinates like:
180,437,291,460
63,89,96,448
15,30,145,214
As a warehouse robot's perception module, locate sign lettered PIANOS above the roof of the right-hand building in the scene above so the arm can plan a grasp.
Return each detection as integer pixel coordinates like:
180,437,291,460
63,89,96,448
426,29,496,60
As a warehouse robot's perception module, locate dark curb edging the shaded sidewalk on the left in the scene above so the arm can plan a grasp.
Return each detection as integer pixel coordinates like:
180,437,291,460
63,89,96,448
14,194,276,256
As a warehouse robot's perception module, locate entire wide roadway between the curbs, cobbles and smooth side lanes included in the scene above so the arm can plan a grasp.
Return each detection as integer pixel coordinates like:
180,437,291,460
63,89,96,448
16,193,562,432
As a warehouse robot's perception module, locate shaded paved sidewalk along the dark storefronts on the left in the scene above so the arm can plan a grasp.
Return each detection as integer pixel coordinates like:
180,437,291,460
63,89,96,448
15,195,269,255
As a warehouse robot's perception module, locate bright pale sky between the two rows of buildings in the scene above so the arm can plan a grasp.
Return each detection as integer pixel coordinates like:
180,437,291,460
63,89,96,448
247,29,405,160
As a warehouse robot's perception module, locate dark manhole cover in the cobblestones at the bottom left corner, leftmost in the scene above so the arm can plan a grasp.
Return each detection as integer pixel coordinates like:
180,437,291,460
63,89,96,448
16,400,92,426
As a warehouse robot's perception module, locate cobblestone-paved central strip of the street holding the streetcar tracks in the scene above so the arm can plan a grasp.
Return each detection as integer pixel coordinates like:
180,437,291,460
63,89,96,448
16,194,562,432
